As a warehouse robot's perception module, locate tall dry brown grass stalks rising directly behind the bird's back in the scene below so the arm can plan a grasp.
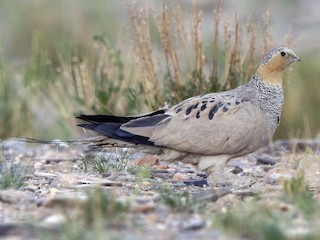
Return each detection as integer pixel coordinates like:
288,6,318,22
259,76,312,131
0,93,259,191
128,1,278,105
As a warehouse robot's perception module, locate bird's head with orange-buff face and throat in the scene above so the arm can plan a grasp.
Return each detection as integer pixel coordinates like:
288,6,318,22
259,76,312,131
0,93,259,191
257,48,300,86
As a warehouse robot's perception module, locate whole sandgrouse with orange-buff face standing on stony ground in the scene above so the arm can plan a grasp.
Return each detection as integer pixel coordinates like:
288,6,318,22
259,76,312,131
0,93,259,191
79,47,300,185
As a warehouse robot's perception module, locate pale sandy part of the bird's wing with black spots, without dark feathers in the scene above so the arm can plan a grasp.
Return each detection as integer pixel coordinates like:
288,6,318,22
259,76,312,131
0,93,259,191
145,93,269,156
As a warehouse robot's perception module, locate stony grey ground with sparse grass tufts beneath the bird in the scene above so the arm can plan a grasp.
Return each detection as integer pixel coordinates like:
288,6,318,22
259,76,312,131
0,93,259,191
0,139,320,240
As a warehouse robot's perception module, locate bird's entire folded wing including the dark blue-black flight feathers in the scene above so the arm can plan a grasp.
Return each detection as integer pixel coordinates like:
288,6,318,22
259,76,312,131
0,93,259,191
80,92,269,156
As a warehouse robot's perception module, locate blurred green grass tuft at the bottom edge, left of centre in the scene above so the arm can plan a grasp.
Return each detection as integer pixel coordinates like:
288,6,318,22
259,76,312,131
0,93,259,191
37,188,130,240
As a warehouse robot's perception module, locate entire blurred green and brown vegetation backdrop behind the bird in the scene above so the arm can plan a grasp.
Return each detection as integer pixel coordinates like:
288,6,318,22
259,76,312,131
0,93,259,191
0,0,320,139
